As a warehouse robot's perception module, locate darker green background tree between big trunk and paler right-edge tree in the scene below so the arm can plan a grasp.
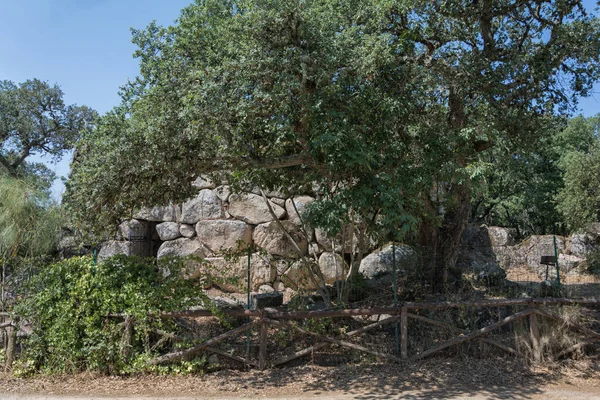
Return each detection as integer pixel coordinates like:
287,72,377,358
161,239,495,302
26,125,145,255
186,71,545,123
471,118,568,238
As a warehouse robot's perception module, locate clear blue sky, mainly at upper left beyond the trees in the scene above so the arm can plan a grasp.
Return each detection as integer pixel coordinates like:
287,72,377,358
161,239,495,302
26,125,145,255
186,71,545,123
0,0,600,197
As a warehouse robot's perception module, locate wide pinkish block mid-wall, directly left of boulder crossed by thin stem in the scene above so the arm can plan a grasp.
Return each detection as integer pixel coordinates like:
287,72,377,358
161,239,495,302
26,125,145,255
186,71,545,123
196,220,252,254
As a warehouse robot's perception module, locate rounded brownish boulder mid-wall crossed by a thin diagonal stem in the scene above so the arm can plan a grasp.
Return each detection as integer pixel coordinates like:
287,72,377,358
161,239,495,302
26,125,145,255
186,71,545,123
253,221,308,258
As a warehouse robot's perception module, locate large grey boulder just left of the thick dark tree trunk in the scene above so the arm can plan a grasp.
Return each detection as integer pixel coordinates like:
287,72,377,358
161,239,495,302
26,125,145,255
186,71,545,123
358,244,418,279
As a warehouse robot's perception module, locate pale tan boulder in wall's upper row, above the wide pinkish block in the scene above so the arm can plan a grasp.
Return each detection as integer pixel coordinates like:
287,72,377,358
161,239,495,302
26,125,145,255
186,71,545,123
227,193,285,225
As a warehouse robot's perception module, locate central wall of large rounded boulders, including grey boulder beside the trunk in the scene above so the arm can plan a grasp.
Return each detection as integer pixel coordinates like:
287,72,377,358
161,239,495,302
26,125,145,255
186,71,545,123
99,179,414,291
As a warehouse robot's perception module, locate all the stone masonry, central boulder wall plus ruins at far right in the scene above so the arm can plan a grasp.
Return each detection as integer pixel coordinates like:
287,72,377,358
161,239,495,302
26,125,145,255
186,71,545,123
99,178,600,291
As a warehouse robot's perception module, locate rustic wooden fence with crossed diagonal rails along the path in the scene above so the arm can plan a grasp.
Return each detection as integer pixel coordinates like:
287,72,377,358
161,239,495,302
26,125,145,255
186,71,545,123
0,298,600,369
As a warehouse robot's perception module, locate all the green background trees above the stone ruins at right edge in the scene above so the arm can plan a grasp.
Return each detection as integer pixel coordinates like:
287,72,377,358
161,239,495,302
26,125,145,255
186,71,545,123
471,112,600,237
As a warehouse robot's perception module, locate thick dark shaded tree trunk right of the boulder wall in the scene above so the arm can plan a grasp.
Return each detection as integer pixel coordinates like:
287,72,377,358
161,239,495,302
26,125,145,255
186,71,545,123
419,183,471,292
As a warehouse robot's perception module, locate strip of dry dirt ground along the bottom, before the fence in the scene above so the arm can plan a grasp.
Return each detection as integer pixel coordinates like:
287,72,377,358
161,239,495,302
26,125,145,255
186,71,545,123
0,357,600,400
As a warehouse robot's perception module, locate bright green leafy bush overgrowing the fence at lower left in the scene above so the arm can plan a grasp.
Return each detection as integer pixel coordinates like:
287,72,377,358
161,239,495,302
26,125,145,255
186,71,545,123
16,256,209,374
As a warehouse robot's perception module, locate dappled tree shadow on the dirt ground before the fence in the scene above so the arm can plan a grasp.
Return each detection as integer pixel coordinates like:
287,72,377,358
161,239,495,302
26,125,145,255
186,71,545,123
209,356,599,400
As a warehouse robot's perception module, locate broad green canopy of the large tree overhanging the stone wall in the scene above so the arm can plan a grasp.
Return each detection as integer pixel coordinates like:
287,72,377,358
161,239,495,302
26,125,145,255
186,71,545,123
68,0,600,282
